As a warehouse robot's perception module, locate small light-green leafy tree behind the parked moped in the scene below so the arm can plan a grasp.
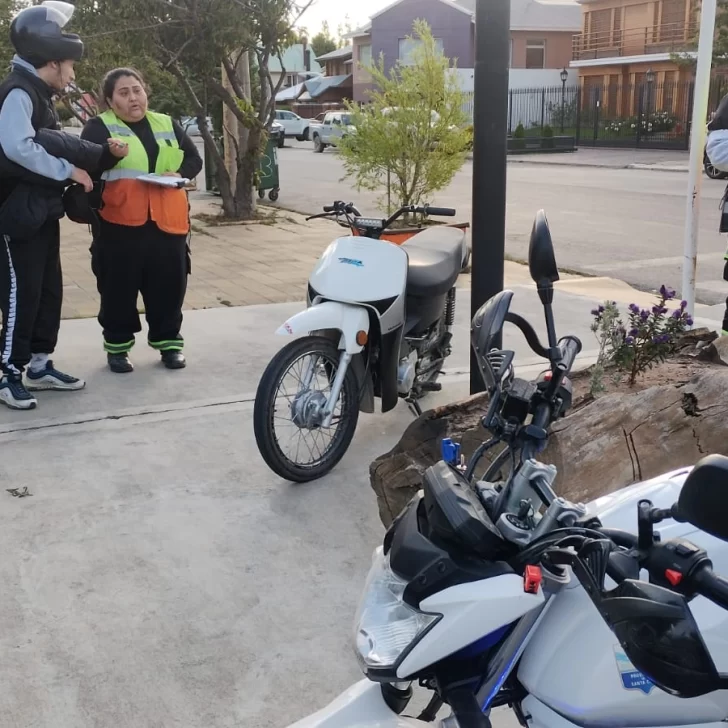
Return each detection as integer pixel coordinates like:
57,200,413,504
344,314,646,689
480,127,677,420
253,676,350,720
339,20,469,209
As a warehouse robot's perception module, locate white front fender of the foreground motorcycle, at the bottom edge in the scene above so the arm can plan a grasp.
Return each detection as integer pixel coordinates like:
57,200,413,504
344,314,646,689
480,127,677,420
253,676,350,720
288,680,432,728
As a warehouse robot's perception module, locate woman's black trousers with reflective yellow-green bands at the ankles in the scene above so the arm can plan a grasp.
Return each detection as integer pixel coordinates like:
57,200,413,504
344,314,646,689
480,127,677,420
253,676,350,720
91,220,190,354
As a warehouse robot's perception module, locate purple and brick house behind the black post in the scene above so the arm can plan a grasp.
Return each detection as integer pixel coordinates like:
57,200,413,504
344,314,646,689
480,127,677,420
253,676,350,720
346,0,581,101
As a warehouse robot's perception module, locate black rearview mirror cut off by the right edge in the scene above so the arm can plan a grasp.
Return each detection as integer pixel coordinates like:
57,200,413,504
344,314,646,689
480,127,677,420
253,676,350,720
678,455,728,541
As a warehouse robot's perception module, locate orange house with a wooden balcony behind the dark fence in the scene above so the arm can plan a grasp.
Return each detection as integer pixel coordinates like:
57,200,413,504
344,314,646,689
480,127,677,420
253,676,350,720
571,0,698,118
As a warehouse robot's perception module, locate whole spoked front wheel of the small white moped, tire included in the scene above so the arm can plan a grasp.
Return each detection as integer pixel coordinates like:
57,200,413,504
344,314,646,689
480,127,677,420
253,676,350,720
253,336,359,483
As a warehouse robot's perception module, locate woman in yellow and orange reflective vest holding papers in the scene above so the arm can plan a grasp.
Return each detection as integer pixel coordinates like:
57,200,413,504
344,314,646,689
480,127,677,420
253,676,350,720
82,68,202,373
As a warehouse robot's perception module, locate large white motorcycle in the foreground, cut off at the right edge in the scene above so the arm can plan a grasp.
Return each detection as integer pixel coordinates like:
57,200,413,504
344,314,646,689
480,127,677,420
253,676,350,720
282,208,728,728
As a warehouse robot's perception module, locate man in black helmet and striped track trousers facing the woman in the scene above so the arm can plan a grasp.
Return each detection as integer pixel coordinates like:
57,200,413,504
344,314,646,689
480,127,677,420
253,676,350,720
0,0,93,410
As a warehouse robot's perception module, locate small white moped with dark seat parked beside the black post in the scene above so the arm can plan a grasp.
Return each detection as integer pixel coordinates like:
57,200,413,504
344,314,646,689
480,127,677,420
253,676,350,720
253,202,469,482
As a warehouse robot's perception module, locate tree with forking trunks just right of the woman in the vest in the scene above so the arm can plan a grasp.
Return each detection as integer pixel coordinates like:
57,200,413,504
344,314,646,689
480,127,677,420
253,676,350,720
109,0,310,219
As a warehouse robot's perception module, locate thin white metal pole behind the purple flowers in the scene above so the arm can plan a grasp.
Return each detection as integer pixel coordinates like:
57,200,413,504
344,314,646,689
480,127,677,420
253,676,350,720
682,0,716,316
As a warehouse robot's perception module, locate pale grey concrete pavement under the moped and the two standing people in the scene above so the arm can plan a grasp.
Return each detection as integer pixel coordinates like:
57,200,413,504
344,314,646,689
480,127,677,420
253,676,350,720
0,264,714,728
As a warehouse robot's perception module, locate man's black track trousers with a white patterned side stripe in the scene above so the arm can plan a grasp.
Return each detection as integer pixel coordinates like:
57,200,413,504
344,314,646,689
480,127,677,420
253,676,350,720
0,220,63,374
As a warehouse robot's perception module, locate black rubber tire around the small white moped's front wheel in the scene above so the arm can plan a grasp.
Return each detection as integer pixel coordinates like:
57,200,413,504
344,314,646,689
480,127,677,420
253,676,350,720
253,336,359,483
